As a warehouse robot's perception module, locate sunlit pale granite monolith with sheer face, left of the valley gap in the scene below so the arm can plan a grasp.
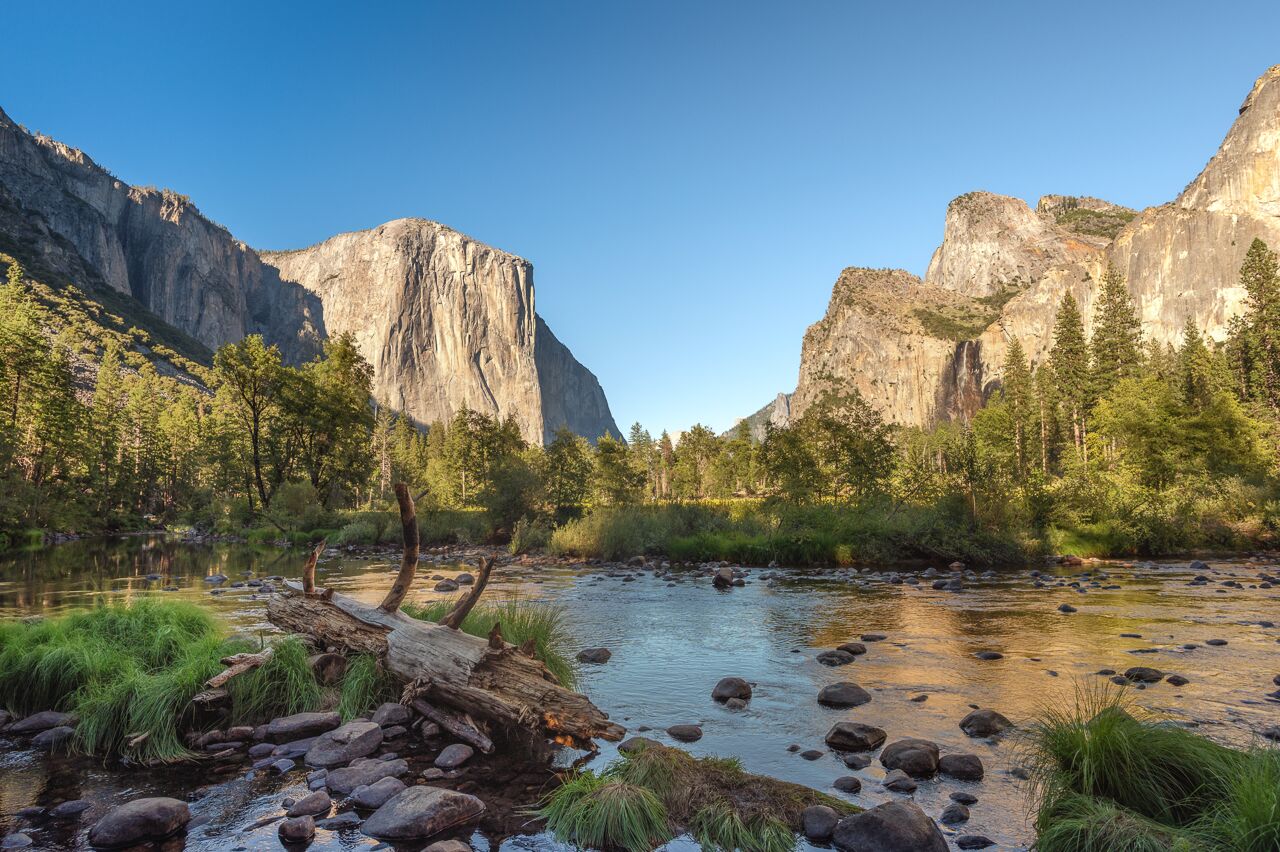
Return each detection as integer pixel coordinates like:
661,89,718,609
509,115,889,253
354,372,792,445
262,219,618,443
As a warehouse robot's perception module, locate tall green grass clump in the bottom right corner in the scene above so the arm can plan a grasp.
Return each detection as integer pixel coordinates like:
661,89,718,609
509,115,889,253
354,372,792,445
1030,691,1280,852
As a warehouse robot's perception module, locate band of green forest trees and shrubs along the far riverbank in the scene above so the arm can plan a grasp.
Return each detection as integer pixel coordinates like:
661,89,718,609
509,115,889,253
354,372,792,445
0,241,1280,563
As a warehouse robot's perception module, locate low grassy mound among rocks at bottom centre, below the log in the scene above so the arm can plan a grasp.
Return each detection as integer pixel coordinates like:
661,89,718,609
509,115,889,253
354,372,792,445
536,743,858,852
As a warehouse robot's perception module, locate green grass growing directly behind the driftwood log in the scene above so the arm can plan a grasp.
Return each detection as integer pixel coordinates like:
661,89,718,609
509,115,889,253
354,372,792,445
404,597,577,690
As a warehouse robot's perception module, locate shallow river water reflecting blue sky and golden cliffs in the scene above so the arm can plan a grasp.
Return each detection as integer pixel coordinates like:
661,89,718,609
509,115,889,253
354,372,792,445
0,537,1280,849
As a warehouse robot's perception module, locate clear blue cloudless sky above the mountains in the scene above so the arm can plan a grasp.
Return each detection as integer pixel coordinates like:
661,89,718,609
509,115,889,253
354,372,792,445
0,0,1280,431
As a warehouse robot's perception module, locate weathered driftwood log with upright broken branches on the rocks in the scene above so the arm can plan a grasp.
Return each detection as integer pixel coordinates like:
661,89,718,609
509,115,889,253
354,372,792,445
268,484,626,747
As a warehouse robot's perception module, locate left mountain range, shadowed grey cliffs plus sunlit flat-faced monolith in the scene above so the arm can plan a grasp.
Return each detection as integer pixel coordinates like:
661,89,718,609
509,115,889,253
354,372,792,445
0,104,620,443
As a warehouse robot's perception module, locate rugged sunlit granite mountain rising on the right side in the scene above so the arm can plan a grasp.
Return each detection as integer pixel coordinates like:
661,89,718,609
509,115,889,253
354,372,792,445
790,65,1280,426
